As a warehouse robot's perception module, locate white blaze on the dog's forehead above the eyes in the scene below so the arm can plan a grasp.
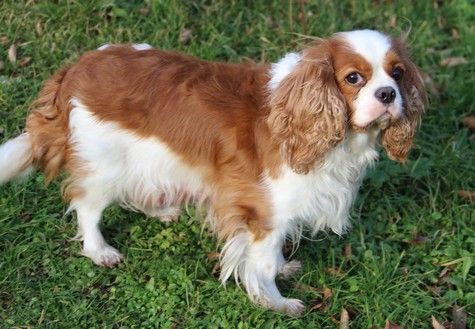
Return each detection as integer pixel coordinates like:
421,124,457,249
338,30,391,67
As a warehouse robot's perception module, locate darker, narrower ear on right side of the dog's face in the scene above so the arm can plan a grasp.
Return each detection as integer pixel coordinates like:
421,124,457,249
381,40,427,163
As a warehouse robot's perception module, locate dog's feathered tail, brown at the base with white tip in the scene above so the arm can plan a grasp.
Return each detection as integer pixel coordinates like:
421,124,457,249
0,67,70,185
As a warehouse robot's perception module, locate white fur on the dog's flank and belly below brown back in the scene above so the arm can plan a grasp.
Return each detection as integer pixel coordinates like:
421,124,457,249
70,99,208,215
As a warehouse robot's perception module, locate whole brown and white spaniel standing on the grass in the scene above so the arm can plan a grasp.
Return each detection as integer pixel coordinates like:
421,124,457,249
0,30,425,314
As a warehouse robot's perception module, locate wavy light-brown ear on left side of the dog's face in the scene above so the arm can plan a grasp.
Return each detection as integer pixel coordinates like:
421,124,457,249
267,40,347,174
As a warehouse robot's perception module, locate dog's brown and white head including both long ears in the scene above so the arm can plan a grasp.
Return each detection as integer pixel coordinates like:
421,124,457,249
267,30,426,173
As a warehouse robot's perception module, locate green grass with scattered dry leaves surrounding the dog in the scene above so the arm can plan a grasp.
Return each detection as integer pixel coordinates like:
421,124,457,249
0,0,475,328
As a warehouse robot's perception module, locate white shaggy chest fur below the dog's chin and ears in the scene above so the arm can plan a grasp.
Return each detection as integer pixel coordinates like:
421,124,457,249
265,130,378,234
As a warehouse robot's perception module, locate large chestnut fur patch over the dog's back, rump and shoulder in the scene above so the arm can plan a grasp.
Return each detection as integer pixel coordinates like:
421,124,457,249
27,46,281,239
